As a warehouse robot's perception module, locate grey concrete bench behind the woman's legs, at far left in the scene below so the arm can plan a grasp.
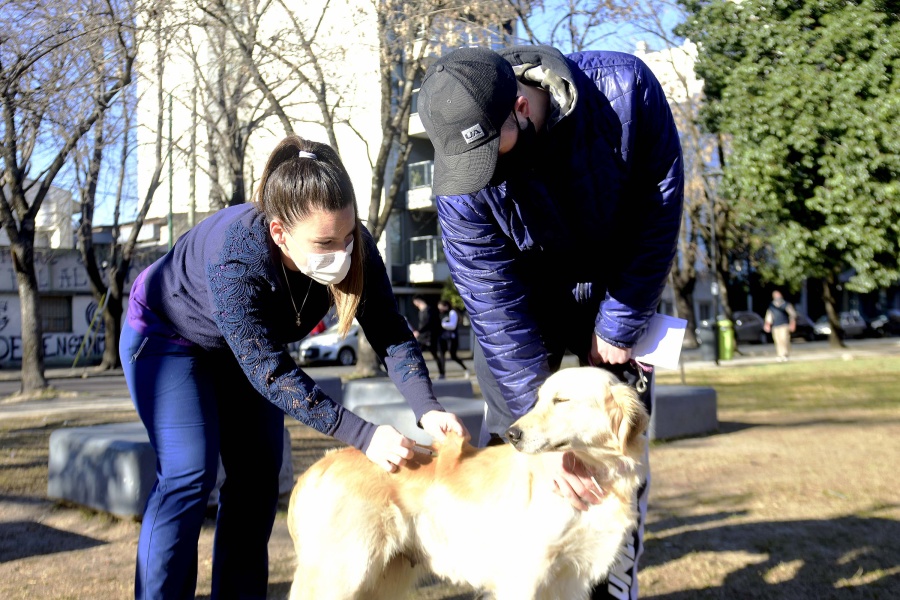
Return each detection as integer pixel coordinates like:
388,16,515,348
47,422,294,518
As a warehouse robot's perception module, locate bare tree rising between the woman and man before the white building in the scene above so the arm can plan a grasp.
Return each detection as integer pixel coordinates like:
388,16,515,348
188,0,513,374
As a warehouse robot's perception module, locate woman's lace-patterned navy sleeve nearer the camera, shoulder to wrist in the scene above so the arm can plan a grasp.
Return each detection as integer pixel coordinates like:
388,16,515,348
207,222,342,435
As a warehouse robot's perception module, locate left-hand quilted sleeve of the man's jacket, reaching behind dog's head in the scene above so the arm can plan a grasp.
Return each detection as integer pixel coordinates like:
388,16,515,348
437,187,550,417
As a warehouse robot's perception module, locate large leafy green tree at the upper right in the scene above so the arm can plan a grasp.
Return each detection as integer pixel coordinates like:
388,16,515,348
679,0,900,344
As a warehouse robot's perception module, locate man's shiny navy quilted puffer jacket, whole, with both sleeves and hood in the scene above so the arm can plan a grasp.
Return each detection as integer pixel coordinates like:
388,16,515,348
437,46,684,414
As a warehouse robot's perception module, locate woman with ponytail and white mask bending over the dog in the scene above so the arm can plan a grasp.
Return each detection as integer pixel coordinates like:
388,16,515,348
119,136,468,599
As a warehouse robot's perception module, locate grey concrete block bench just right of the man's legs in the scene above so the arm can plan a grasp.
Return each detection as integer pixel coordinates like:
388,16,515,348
650,385,719,440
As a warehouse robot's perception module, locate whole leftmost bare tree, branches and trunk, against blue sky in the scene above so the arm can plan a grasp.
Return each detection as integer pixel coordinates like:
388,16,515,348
0,0,136,393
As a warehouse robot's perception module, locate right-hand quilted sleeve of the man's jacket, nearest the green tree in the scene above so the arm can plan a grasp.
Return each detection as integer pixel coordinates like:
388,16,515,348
580,52,684,348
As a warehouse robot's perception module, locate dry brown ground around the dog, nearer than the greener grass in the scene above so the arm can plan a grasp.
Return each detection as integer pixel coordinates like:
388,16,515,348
0,407,900,600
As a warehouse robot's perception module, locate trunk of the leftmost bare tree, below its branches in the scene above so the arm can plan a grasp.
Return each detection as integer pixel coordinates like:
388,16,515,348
10,241,49,393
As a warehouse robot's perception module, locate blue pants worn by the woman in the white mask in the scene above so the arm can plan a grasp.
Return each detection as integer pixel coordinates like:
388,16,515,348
119,324,284,600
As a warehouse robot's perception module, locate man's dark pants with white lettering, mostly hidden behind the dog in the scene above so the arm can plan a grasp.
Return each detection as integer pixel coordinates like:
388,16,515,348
472,343,653,600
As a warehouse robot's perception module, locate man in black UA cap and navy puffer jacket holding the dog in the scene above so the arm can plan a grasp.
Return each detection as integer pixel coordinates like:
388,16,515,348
419,46,684,599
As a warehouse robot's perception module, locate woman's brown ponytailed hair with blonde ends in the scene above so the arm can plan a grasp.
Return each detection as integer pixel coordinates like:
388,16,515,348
253,135,366,336
